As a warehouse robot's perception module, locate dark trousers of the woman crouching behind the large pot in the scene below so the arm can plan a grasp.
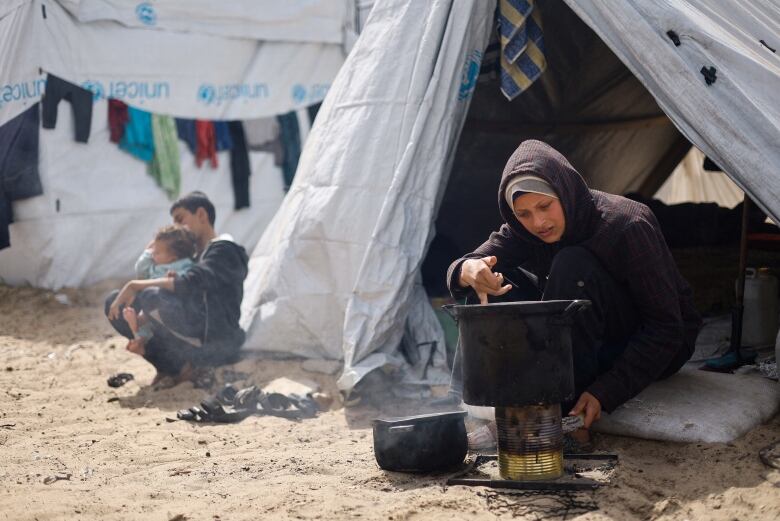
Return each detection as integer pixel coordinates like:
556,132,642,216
450,246,686,408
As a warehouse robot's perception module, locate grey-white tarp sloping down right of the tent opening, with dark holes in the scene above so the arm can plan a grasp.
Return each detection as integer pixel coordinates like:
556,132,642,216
566,0,780,218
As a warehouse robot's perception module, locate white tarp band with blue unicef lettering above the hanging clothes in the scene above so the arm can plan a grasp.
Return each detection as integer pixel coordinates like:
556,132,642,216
0,0,345,124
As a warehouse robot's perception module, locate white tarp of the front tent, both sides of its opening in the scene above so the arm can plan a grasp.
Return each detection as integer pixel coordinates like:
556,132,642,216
242,0,780,390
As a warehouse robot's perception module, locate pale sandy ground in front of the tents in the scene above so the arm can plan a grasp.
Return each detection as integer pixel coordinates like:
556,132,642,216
0,286,780,521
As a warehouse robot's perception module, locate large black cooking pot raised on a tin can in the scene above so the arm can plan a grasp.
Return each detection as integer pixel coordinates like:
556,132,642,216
444,300,590,407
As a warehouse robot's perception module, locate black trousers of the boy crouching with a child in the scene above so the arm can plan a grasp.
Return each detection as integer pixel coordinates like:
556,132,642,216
105,288,205,375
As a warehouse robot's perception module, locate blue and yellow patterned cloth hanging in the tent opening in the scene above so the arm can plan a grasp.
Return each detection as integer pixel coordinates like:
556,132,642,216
497,0,547,101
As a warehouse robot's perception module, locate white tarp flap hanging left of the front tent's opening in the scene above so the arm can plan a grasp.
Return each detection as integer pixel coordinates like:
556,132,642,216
242,0,493,389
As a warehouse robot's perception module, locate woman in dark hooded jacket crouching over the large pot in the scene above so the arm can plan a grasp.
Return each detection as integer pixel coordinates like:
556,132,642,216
447,140,701,428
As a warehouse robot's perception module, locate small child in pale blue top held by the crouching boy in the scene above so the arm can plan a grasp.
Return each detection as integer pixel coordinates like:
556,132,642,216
122,224,197,355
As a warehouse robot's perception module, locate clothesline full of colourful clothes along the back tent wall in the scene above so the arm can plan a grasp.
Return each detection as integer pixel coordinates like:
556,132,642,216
0,74,320,249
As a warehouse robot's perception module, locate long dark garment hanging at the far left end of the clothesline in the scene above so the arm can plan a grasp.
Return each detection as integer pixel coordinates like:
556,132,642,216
0,103,43,249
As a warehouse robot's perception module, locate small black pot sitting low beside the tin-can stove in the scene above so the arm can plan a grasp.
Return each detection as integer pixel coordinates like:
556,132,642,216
372,411,468,472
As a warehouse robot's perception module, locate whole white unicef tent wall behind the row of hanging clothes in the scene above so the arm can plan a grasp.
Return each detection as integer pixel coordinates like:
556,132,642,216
0,0,351,289
